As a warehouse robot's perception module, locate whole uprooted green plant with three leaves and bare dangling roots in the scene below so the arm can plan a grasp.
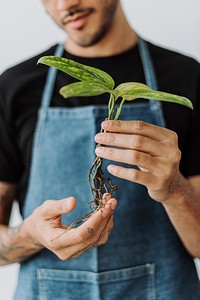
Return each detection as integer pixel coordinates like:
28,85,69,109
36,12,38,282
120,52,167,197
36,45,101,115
38,56,193,228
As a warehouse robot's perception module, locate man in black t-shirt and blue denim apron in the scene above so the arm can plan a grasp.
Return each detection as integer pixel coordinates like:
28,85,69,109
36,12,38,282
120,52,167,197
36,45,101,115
0,0,200,300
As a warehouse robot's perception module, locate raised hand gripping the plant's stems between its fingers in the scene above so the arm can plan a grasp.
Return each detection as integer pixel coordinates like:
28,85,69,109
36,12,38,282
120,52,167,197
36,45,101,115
95,121,181,202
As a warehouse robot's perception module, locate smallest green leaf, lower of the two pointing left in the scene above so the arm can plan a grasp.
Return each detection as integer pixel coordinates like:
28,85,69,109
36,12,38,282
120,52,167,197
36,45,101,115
60,82,109,98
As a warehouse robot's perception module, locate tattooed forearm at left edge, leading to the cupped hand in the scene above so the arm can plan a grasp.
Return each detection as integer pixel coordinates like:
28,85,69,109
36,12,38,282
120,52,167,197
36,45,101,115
0,223,41,265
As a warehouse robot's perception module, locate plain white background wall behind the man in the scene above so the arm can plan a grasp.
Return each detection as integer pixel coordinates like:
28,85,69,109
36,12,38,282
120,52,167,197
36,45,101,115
0,0,200,300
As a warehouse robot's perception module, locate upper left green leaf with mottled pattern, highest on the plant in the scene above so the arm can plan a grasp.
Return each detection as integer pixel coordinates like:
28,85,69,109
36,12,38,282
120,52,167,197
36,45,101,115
38,56,115,90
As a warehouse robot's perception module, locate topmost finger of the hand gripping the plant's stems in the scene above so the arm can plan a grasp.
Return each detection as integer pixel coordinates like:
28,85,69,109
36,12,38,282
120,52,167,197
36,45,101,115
101,120,176,141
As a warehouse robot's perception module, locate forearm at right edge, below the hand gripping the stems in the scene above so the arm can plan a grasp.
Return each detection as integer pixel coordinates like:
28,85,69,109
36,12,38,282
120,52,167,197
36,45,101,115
163,176,200,258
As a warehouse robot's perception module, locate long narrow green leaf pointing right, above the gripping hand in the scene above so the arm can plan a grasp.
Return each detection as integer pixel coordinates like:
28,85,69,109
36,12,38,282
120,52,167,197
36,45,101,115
114,82,193,109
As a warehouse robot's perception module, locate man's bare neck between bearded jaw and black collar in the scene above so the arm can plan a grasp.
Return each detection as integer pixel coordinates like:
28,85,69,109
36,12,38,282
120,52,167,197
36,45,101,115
65,5,138,57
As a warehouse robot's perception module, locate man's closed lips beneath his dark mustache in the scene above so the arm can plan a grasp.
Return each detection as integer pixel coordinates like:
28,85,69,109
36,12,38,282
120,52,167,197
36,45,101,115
61,8,94,25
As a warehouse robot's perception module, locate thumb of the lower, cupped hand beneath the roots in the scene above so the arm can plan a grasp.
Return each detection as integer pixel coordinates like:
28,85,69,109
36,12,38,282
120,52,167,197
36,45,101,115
42,197,76,218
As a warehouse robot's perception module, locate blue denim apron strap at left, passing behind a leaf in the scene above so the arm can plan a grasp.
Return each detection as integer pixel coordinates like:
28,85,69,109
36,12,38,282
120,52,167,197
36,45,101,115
41,44,64,108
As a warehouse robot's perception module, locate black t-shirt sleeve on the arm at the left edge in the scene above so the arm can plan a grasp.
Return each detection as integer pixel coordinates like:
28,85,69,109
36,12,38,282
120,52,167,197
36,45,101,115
0,76,22,183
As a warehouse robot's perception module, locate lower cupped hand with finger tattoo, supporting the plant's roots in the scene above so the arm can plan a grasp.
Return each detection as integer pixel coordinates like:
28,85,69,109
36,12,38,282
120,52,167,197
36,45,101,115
23,193,117,260
